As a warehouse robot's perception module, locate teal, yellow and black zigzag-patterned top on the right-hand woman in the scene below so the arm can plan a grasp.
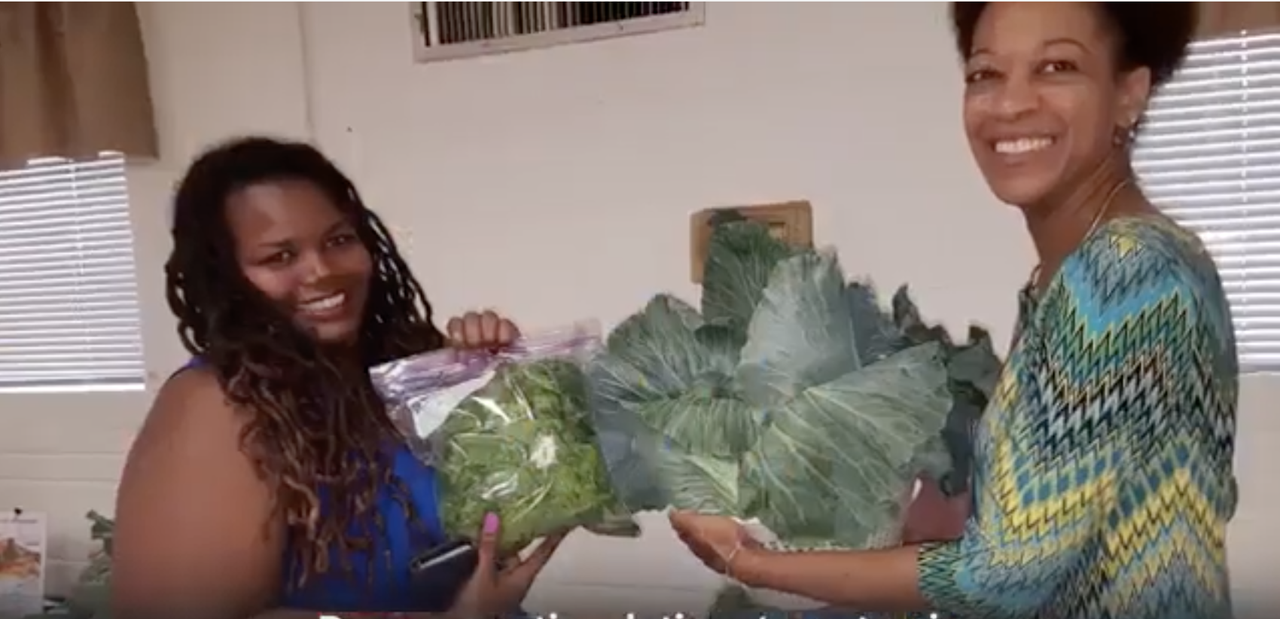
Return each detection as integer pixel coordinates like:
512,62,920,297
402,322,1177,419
918,231,1236,619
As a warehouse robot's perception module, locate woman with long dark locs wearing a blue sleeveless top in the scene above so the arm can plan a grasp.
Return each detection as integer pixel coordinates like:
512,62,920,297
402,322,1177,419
113,138,558,619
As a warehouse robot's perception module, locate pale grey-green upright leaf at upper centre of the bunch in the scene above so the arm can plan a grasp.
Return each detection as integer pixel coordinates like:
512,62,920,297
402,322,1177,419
737,252,861,409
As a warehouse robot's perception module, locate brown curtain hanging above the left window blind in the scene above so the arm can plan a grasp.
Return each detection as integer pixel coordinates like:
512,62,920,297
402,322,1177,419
0,3,159,166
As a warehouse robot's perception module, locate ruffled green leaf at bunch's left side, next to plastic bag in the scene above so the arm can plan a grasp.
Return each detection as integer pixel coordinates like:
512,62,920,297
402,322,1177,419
588,295,758,510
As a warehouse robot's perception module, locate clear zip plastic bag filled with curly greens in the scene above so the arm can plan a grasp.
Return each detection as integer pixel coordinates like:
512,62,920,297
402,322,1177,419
371,322,639,551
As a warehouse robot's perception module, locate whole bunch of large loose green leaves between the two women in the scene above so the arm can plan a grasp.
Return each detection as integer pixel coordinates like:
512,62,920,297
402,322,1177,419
589,216,1000,549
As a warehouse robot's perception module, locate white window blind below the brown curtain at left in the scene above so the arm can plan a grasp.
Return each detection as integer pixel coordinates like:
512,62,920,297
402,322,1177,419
0,153,145,391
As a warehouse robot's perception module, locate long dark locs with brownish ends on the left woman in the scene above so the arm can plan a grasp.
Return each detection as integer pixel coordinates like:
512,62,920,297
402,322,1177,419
165,137,444,587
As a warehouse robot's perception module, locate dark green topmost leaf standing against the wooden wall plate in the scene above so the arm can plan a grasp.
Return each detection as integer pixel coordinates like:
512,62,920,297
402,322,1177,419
703,220,796,331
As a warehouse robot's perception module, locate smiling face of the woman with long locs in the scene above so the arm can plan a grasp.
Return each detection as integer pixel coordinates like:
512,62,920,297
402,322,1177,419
227,180,374,343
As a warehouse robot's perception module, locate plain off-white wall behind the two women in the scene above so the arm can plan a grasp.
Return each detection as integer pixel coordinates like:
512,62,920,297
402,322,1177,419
0,3,1280,613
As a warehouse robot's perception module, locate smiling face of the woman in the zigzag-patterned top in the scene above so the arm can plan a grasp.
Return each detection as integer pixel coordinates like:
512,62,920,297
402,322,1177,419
964,3,1149,207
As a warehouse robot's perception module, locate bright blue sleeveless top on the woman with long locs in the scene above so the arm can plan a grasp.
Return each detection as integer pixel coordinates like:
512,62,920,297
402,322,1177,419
175,359,452,613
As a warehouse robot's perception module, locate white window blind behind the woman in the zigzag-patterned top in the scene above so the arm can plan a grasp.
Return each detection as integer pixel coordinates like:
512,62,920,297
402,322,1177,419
1134,32,1280,372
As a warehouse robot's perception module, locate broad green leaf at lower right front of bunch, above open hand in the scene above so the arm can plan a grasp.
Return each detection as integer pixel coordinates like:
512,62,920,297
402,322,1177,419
739,344,951,547
